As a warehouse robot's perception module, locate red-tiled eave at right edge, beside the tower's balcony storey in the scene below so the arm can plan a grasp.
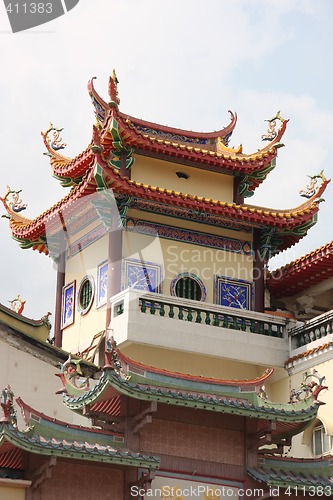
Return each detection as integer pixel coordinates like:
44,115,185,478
267,241,333,298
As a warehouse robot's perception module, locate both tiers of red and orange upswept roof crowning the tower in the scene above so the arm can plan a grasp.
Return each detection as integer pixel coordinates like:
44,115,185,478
1,76,329,254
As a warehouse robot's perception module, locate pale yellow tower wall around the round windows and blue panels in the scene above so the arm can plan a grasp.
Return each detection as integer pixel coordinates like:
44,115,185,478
62,199,253,353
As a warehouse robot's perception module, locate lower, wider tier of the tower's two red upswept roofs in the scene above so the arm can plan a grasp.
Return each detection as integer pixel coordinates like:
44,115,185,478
1,155,330,254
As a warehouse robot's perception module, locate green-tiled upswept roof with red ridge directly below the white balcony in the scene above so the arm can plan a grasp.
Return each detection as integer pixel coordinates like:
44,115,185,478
63,350,320,426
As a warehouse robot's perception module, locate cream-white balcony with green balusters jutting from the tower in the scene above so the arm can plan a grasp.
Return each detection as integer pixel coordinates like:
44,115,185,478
110,289,288,367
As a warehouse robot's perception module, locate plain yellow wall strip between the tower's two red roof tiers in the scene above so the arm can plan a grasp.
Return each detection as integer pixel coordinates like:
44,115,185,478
131,155,233,203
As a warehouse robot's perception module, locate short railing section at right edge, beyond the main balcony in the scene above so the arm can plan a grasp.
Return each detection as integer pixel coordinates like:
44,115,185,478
289,311,333,349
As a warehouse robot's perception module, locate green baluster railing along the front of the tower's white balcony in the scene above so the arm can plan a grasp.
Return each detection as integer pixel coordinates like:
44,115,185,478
115,293,286,338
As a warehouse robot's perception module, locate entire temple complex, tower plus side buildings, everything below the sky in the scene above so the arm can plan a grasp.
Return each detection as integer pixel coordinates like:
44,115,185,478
0,73,333,500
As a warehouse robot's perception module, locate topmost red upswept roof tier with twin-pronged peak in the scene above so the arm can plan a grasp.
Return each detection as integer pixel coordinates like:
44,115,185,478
42,75,288,195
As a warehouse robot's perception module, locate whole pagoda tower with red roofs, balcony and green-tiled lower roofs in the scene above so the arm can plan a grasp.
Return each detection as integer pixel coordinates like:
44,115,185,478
0,73,331,500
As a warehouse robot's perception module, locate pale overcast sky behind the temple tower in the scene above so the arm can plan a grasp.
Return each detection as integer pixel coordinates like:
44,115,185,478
0,0,333,321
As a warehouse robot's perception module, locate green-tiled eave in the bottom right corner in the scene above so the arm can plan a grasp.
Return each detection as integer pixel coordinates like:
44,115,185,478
247,456,333,490
